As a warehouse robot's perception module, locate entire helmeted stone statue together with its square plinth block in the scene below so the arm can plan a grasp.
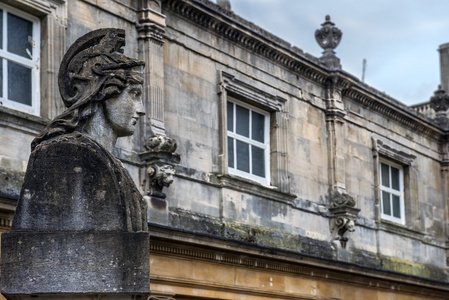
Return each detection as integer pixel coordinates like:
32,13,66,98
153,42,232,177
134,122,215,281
1,28,149,299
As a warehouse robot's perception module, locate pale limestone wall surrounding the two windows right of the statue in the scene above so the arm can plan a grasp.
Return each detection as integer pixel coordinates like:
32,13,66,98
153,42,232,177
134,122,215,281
163,0,447,280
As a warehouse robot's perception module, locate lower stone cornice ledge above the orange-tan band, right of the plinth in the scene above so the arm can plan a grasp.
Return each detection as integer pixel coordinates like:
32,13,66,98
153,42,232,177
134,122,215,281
150,224,449,298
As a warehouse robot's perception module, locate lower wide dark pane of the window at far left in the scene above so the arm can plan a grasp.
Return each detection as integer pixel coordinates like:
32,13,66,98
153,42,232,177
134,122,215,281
8,61,31,106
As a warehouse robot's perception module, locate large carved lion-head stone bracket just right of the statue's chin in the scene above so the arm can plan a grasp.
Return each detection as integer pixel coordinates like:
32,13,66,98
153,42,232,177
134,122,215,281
140,135,181,199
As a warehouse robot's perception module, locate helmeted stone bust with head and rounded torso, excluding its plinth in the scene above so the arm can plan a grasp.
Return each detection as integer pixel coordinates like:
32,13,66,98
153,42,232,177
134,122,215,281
13,29,148,231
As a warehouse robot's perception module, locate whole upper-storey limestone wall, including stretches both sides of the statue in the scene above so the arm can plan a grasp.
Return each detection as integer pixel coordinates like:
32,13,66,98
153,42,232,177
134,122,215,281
0,0,448,288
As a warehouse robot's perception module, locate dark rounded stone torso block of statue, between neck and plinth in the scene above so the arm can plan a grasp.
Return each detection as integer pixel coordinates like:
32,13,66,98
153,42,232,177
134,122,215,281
13,132,146,232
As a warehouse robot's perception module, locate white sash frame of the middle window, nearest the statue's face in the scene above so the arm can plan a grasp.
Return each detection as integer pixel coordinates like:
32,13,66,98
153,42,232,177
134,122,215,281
227,97,270,185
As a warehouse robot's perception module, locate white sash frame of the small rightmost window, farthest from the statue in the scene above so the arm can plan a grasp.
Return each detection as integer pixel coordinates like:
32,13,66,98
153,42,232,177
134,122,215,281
379,159,405,225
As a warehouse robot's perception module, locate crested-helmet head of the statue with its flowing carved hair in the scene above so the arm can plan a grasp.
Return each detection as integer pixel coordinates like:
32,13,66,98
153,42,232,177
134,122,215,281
32,28,145,149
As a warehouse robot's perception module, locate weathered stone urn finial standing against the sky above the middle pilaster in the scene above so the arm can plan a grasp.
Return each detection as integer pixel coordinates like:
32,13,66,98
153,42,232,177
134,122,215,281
315,15,343,69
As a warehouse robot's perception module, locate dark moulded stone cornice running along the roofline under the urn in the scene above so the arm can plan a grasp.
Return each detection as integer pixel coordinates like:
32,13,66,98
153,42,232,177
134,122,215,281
163,0,445,140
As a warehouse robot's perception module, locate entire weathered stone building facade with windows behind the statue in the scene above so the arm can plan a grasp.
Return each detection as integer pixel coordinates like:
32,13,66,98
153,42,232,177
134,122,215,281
0,0,449,300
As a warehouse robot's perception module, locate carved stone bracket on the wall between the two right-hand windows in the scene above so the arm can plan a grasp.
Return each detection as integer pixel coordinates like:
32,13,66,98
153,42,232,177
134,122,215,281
329,191,360,248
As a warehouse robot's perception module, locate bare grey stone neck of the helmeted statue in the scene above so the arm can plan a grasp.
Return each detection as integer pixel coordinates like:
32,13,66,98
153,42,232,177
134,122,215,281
83,105,117,153
